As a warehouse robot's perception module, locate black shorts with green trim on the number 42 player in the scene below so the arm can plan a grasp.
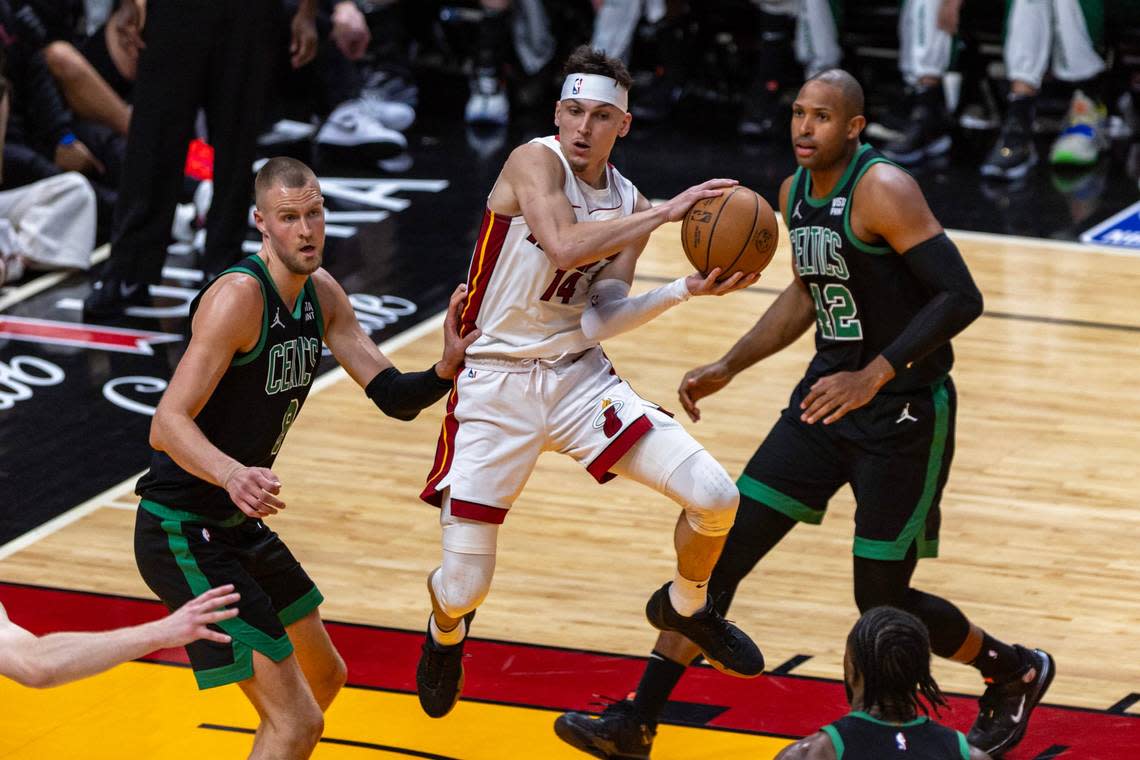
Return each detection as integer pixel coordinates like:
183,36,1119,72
736,377,958,559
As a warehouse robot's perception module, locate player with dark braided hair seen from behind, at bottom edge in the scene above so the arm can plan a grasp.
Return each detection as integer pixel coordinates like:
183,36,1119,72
775,607,990,760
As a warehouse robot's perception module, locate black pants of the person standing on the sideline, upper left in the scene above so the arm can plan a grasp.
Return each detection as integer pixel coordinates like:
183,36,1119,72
104,0,282,283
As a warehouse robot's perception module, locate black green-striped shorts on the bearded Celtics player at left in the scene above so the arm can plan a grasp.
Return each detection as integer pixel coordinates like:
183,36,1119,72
135,499,324,688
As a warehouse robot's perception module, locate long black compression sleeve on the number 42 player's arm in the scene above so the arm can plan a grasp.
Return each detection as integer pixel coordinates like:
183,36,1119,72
882,232,982,373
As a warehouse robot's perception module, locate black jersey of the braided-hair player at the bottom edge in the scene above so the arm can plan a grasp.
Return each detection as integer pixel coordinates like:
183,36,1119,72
821,712,970,760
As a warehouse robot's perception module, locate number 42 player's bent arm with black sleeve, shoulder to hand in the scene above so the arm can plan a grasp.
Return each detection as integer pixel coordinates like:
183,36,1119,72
801,164,982,425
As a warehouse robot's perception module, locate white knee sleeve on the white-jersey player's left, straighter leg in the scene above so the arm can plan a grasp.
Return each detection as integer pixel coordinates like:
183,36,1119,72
431,493,498,618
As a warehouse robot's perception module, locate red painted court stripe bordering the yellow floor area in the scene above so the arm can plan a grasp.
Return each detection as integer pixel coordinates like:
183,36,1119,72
0,583,1140,760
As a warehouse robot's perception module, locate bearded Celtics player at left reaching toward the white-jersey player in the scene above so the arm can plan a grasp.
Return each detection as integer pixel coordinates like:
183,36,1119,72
135,158,474,759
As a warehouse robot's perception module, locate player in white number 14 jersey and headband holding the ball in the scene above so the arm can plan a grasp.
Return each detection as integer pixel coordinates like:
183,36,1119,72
416,47,764,717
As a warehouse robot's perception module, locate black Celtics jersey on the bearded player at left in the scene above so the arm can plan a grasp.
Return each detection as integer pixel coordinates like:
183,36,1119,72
136,255,324,520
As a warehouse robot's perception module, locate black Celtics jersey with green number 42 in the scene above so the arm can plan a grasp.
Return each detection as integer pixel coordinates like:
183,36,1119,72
784,145,954,393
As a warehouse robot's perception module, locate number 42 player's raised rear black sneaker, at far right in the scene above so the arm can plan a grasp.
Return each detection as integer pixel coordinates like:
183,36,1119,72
966,645,1056,758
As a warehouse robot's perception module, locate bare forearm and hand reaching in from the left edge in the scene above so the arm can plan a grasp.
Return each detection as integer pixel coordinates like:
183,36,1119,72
0,585,239,688
